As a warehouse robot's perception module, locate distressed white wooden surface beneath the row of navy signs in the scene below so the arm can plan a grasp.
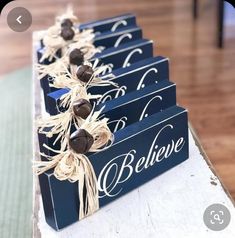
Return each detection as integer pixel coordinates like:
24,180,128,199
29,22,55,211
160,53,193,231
33,32,235,238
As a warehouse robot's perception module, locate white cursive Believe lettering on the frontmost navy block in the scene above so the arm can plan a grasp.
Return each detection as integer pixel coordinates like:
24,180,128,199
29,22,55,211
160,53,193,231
98,124,186,198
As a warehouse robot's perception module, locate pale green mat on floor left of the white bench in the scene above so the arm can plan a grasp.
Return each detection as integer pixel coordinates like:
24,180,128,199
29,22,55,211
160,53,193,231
0,68,32,238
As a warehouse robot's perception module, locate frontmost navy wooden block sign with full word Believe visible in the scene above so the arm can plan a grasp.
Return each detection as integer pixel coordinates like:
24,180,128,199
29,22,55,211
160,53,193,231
39,106,189,230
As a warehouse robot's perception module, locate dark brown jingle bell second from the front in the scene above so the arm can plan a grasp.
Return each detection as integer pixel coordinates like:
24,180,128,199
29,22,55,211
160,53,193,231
73,98,92,119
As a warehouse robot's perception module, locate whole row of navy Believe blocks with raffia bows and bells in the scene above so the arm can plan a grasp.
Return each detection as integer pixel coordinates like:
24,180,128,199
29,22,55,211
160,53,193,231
33,9,189,230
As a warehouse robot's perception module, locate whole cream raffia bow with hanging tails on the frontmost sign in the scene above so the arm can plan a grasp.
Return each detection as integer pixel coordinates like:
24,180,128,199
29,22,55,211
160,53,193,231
33,109,113,219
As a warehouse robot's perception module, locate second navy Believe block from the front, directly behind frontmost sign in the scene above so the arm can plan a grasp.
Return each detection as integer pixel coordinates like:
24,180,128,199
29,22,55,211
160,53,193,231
38,80,176,160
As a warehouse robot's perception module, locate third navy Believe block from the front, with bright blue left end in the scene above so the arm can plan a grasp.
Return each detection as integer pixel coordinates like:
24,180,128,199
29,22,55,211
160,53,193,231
45,56,169,115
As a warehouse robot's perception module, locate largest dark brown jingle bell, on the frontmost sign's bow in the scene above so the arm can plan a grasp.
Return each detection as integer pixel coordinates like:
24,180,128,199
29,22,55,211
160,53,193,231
69,128,94,154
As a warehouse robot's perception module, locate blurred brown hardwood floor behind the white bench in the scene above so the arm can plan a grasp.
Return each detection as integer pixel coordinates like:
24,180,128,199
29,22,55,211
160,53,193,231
0,0,235,198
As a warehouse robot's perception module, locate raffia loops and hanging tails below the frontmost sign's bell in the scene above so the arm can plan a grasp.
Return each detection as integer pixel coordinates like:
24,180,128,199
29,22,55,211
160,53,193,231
33,150,99,220
